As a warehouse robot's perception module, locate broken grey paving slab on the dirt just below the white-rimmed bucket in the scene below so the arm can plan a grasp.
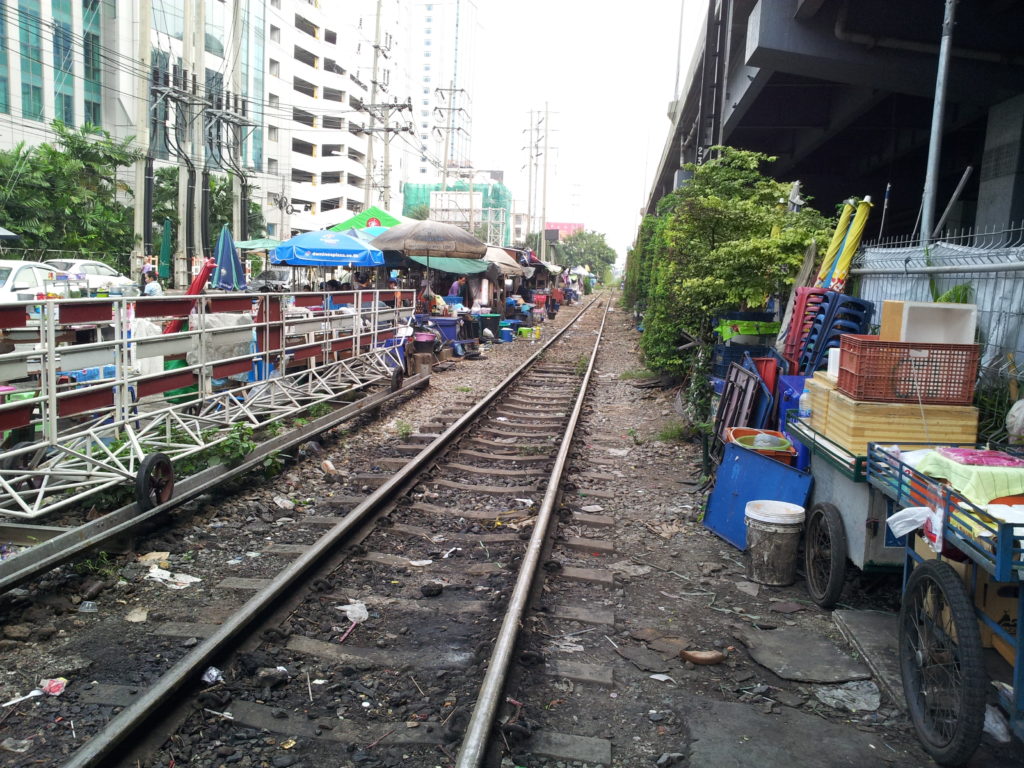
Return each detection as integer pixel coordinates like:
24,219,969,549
738,627,871,683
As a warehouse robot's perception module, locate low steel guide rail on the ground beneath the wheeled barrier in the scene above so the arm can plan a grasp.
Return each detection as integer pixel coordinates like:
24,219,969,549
0,376,430,594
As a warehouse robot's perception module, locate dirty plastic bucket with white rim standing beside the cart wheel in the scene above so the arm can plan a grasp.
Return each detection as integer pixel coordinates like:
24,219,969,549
745,500,805,587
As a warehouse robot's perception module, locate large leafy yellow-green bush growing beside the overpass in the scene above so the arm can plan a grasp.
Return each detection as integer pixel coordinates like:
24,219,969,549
625,146,829,374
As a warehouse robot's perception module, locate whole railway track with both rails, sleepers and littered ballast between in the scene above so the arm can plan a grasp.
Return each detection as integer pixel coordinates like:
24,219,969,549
0,296,610,766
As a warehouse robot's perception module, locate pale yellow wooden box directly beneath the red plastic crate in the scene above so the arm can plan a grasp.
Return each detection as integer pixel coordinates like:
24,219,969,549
815,389,978,456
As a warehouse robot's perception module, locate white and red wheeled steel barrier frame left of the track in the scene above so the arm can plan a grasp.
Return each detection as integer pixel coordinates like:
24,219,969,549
0,291,415,519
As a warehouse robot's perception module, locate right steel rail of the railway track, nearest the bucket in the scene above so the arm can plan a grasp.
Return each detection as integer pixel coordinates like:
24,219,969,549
456,301,610,768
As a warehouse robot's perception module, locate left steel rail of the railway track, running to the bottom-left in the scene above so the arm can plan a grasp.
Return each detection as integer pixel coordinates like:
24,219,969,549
63,298,597,768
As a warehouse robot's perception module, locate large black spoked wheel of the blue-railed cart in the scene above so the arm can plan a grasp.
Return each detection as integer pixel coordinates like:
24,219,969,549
899,560,985,766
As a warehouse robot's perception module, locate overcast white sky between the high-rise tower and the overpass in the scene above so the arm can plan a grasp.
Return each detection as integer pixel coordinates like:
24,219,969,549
471,0,707,260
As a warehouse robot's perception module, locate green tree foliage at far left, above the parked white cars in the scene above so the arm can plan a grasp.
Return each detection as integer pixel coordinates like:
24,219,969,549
0,121,138,270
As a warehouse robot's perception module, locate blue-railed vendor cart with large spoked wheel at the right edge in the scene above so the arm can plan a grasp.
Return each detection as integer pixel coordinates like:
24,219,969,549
867,443,1024,766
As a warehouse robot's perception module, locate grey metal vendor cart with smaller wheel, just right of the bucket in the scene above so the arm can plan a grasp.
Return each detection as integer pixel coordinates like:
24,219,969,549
786,419,904,608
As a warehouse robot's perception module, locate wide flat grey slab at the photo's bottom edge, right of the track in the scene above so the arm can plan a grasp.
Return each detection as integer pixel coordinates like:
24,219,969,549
679,696,891,768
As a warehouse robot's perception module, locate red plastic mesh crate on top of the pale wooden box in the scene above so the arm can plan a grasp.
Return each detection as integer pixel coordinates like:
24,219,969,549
838,334,981,406
